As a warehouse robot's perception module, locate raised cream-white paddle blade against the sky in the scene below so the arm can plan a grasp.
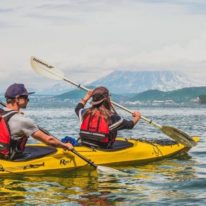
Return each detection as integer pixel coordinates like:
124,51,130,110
31,57,64,80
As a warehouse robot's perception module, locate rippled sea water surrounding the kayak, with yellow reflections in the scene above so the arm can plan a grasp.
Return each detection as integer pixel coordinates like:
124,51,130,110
0,106,206,206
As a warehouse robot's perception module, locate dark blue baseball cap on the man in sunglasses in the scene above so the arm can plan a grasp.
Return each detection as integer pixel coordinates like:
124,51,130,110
4,83,34,99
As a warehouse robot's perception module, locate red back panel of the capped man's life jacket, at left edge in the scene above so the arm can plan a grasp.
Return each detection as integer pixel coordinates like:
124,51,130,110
0,108,17,158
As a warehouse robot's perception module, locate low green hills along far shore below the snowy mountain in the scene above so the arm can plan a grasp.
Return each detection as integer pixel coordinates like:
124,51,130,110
54,87,206,104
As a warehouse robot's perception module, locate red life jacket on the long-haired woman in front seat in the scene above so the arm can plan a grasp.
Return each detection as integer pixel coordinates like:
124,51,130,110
80,111,114,146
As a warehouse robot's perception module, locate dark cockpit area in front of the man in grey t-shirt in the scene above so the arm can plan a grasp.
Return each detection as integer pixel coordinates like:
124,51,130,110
12,146,57,162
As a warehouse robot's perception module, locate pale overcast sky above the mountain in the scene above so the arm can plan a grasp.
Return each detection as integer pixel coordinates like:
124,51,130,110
0,0,206,91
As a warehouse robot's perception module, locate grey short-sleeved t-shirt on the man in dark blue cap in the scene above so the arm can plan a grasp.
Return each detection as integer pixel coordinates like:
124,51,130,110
4,108,39,140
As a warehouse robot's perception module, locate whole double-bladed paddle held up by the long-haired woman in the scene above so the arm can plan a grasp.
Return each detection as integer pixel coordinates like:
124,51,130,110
31,57,196,148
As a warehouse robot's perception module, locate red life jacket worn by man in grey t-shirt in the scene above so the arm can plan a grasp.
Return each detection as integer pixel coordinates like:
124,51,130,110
0,109,27,158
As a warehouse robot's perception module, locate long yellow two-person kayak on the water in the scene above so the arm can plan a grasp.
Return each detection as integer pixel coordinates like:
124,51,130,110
0,137,199,175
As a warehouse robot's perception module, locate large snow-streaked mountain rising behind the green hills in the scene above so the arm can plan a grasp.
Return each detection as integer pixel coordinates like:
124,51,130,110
90,71,197,94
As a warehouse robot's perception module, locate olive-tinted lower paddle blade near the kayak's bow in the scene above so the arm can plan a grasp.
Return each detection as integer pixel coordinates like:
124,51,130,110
161,126,197,148
